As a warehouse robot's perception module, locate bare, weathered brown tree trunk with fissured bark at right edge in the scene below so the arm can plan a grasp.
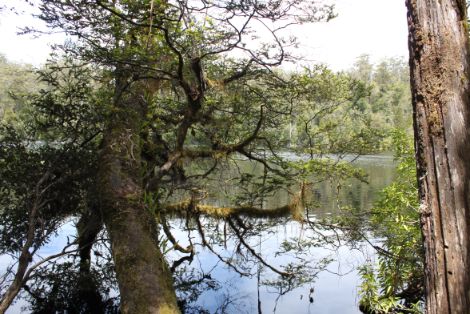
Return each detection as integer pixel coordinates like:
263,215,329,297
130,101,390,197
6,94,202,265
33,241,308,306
407,0,470,314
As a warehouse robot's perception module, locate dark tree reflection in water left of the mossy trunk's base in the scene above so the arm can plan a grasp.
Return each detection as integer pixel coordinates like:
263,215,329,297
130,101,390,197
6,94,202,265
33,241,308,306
17,228,119,313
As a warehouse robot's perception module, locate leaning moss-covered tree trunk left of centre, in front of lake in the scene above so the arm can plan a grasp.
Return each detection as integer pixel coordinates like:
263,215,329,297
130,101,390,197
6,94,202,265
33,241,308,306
98,78,179,314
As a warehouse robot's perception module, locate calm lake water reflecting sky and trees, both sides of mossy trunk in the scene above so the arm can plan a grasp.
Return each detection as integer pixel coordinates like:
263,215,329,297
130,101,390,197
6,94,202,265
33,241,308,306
4,156,395,314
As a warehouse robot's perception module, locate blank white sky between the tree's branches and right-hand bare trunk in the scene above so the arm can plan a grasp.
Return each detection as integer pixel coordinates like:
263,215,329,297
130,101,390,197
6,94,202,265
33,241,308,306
297,0,408,70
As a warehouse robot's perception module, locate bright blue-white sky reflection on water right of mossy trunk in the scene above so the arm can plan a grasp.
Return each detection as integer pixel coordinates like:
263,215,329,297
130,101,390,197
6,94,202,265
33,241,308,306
166,218,372,313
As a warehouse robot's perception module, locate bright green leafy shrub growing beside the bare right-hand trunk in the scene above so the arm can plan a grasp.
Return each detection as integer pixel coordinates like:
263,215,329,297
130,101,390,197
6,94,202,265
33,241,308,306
360,131,424,313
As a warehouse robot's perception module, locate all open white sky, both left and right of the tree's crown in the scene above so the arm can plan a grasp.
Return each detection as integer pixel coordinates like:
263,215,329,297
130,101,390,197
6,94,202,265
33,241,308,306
0,0,408,70
